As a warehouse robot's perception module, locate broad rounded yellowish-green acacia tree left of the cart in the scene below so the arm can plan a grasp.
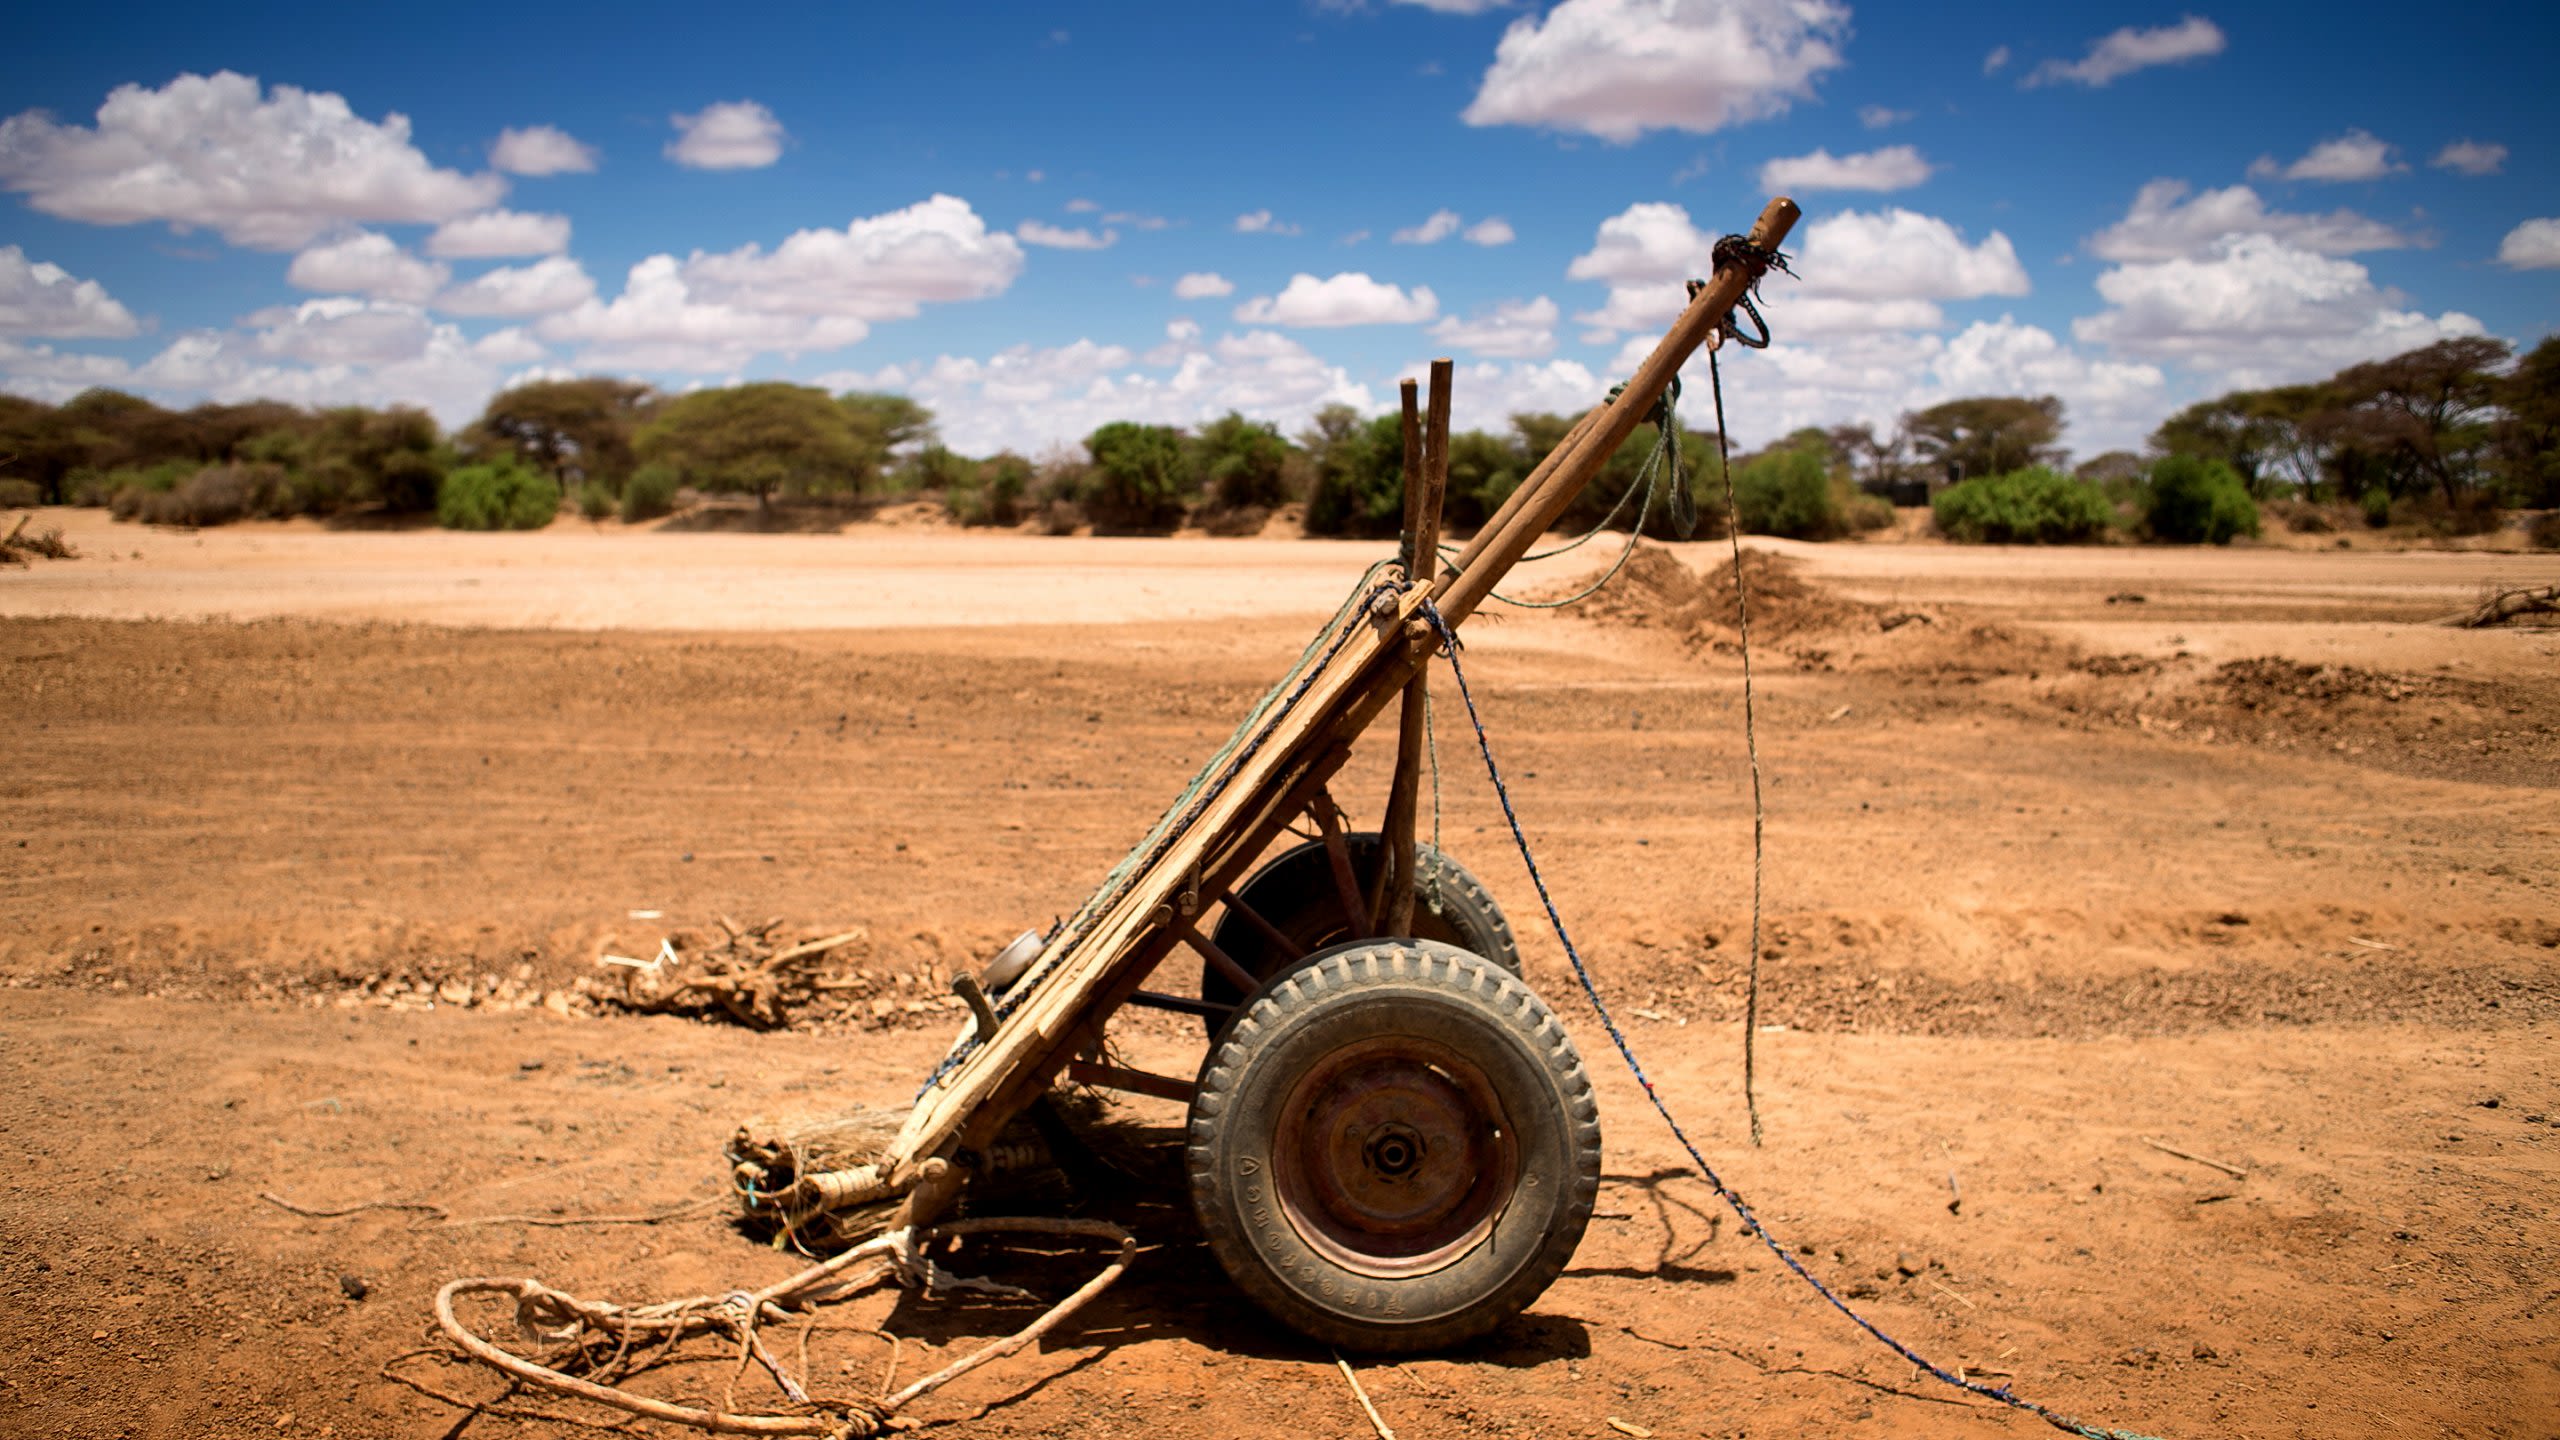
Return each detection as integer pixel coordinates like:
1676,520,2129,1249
632,379,863,512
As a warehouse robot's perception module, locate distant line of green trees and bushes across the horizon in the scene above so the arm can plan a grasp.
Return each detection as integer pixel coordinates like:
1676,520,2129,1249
0,338,2560,541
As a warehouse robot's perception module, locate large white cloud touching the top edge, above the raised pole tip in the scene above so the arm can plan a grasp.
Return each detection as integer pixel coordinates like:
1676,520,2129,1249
1464,0,1848,143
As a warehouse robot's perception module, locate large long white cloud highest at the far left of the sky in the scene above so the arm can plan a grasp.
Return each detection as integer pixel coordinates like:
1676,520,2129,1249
0,69,507,251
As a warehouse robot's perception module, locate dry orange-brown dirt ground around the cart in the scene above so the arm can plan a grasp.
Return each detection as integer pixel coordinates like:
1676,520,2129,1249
0,515,2560,1440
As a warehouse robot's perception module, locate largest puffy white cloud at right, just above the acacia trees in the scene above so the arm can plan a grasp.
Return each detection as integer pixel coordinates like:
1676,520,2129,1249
2071,236,2481,387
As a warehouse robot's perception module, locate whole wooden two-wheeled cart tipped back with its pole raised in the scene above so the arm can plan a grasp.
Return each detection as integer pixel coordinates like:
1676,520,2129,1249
858,197,1797,1350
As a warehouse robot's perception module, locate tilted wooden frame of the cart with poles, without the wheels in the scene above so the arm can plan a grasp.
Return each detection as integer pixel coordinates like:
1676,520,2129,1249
873,197,1797,1227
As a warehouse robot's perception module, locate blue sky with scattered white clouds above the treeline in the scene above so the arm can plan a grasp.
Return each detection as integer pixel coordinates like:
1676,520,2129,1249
0,0,2560,456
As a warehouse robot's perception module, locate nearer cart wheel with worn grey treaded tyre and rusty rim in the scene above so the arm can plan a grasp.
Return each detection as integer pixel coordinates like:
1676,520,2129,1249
1183,940,1600,1350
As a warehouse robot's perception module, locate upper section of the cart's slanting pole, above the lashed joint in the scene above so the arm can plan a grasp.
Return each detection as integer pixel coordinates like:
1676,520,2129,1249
1436,195,1800,625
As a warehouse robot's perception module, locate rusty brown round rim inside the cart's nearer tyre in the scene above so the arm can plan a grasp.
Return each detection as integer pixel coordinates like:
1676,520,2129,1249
1272,1035,1521,1279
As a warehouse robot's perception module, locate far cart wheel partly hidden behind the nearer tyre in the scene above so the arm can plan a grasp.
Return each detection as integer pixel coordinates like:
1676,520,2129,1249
1201,830,1521,1019
